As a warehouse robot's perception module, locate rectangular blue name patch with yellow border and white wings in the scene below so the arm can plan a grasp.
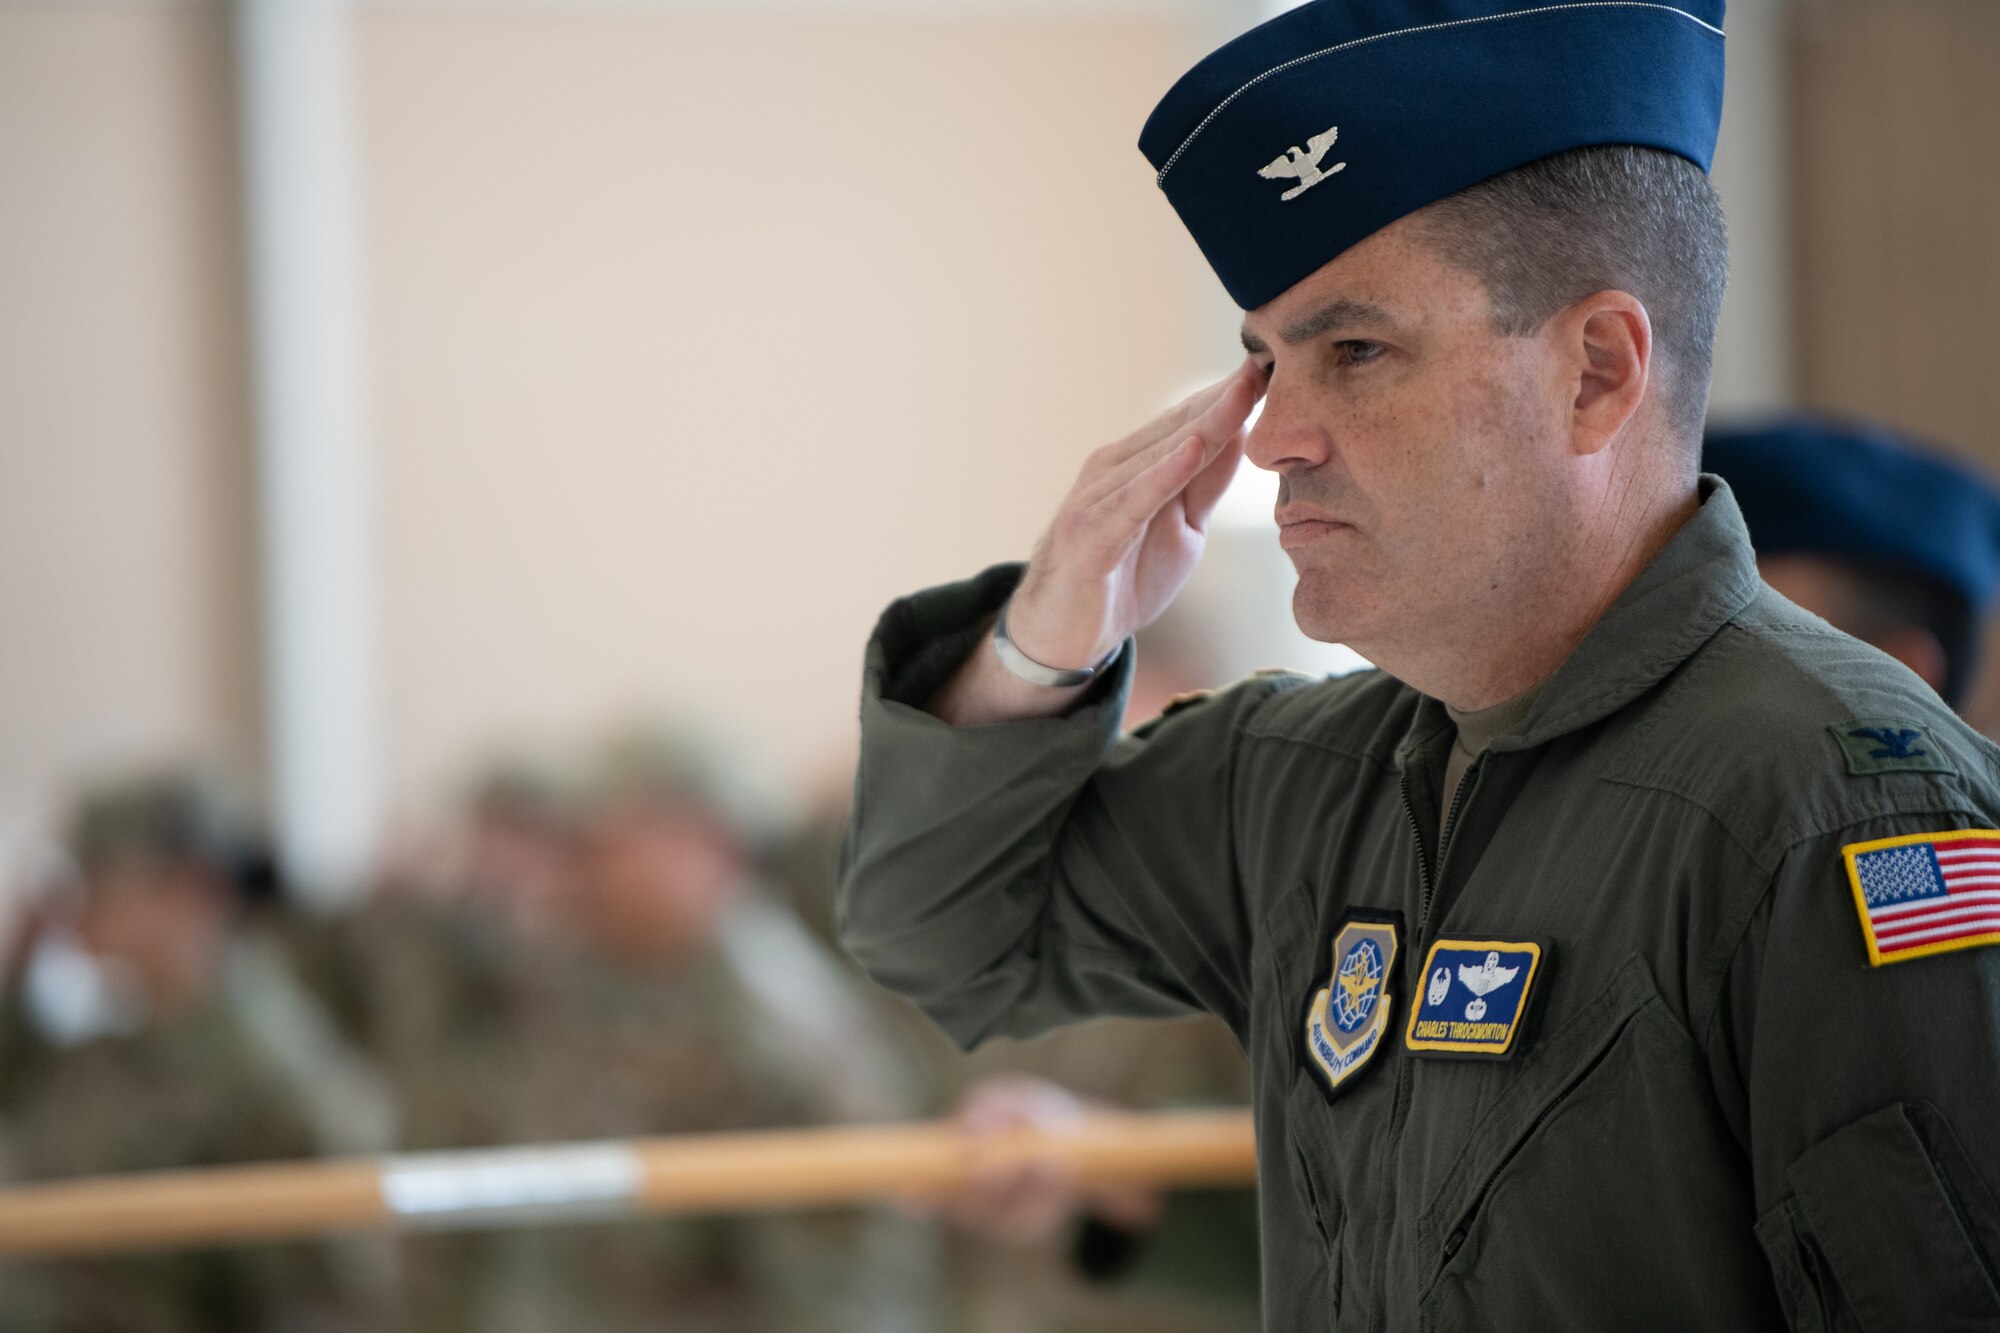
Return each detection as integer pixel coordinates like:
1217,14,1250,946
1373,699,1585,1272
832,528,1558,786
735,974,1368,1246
1402,939,1548,1061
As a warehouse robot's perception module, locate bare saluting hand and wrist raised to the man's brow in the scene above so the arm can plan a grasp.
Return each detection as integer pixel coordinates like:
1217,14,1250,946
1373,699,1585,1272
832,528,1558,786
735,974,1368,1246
930,360,1264,725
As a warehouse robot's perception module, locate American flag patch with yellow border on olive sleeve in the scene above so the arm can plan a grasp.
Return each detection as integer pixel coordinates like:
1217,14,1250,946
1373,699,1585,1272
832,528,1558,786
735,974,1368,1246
1840,829,2000,967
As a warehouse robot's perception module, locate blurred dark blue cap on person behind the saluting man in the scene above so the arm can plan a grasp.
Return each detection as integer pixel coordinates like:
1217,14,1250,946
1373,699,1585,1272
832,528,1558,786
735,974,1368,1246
1702,416,2000,612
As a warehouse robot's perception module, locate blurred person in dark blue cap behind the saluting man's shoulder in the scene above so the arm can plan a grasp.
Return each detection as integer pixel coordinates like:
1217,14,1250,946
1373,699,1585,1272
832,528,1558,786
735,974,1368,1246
1702,414,2000,711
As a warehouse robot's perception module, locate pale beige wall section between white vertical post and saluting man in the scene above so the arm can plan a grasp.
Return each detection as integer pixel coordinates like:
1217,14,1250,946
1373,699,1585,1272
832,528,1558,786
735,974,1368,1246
358,8,1200,808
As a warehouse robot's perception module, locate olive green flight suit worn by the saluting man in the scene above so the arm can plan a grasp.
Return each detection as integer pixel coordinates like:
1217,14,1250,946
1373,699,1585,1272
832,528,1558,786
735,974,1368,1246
840,478,2000,1333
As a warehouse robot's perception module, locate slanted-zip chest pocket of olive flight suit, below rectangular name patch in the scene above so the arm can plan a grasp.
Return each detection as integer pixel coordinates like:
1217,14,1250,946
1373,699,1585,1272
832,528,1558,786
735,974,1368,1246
1416,957,1782,1329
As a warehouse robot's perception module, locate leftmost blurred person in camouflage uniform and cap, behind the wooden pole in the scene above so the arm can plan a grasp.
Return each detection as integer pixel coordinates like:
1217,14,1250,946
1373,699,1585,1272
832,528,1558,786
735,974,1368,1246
0,773,388,1333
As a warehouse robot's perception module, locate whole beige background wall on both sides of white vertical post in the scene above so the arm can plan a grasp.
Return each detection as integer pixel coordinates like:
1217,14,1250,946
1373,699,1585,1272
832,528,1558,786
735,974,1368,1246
0,0,1208,827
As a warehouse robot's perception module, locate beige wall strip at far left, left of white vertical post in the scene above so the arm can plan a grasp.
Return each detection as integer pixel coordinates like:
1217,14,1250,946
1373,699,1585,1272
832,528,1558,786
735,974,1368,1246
0,4,258,833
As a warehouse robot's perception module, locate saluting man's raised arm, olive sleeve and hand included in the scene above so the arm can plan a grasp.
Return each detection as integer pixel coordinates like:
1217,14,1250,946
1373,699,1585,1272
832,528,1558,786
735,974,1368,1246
840,368,1272,1045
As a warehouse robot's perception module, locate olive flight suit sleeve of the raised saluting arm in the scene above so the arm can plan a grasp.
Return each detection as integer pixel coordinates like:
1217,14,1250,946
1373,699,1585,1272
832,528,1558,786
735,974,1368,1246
838,566,1272,1047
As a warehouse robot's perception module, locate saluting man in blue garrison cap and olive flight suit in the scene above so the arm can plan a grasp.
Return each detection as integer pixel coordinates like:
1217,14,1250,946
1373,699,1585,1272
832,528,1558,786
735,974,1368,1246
842,0,2000,1331
